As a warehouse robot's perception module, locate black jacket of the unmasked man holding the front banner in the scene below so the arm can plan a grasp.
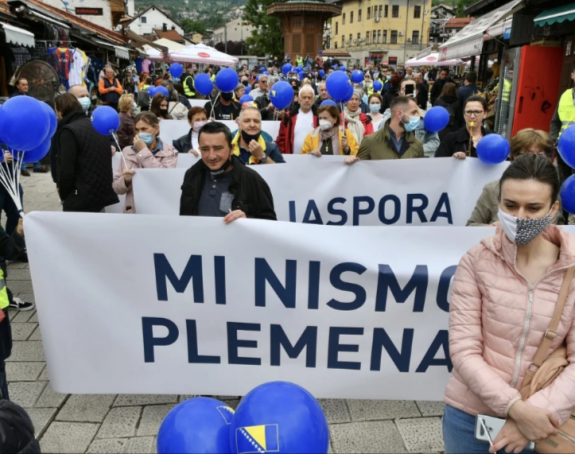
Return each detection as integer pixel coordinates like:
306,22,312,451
180,156,277,221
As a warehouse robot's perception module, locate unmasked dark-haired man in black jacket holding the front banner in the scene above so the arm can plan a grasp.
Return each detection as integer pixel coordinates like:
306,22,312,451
180,122,277,220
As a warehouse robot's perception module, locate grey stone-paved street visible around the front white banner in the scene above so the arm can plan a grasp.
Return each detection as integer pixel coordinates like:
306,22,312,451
3,173,443,453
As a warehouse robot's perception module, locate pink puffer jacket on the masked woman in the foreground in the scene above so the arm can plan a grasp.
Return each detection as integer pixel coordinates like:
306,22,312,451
445,225,575,424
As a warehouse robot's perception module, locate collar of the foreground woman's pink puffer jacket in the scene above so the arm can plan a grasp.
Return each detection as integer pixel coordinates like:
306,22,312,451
481,224,575,273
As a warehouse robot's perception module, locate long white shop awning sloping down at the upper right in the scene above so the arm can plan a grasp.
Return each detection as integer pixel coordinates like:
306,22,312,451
439,0,523,61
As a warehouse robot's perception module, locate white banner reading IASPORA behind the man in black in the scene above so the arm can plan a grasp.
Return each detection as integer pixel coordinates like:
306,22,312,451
133,159,508,226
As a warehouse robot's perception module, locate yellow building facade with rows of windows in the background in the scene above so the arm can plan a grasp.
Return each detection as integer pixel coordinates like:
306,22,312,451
331,0,431,66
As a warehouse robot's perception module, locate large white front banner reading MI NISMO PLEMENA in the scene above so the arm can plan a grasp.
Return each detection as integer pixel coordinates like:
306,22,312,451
25,212,516,400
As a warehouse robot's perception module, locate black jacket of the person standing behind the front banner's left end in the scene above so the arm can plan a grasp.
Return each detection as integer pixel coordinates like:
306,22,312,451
57,110,118,212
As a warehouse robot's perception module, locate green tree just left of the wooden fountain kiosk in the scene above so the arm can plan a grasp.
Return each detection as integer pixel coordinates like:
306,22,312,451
243,0,284,58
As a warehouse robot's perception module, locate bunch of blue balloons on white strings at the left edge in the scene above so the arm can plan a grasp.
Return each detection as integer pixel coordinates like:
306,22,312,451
0,96,58,216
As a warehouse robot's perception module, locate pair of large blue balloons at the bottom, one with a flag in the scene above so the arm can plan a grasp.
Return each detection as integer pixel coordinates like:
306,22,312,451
157,382,329,454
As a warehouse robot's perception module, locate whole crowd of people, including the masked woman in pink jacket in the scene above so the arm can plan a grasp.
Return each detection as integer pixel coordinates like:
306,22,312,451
0,56,575,453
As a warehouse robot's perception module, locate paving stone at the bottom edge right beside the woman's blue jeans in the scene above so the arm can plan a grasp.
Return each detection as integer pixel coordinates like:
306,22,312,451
396,418,444,452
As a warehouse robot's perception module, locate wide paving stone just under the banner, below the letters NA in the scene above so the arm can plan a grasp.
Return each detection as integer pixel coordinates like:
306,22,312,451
347,400,421,421
